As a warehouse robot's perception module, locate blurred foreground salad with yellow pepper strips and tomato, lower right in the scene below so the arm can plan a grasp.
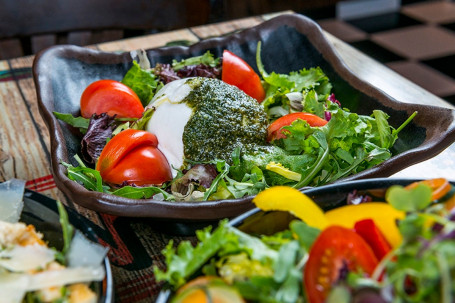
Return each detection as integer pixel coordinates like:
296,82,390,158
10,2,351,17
155,179,455,303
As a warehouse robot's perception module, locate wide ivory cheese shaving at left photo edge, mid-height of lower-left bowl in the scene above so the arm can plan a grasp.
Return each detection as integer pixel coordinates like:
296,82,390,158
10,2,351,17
0,244,55,272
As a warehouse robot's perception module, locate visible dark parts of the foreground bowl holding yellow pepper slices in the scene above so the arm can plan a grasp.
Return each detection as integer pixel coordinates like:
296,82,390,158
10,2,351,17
155,178,446,303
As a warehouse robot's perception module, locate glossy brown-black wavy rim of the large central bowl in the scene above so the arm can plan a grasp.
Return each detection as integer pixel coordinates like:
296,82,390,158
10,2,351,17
33,14,455,222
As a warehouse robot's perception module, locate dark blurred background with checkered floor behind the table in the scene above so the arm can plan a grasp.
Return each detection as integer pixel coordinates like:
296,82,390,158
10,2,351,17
0,0,455,104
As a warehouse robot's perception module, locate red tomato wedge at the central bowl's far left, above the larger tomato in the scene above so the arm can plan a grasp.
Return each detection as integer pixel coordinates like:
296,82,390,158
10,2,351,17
81,80,144,118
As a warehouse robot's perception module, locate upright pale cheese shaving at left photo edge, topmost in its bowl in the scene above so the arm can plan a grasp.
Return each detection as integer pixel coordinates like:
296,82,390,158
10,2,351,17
0,179,25,223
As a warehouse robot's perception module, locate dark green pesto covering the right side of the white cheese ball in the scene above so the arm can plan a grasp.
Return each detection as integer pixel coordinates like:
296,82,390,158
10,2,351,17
182,78,267,163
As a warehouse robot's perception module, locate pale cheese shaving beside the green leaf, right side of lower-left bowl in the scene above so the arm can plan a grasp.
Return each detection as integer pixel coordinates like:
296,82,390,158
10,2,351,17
67,231,108,267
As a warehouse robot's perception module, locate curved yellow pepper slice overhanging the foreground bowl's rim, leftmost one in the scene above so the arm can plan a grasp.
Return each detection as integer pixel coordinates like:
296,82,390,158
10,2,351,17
253,186,329,230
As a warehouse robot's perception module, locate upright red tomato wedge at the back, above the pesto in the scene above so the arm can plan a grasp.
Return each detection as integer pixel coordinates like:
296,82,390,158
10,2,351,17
221,50,265,102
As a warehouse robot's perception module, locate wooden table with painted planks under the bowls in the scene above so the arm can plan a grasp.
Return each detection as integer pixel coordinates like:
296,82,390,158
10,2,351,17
0,10,455,302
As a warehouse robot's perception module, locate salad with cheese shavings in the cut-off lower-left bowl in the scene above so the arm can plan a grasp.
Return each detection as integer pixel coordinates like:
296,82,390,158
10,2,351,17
0,179,107,303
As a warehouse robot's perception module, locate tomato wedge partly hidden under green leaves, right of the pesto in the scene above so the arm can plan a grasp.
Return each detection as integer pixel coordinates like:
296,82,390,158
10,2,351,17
267,112,328,142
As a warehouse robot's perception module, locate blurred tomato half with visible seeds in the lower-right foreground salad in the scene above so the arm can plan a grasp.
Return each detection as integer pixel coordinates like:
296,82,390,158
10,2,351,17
304,225,378,303
